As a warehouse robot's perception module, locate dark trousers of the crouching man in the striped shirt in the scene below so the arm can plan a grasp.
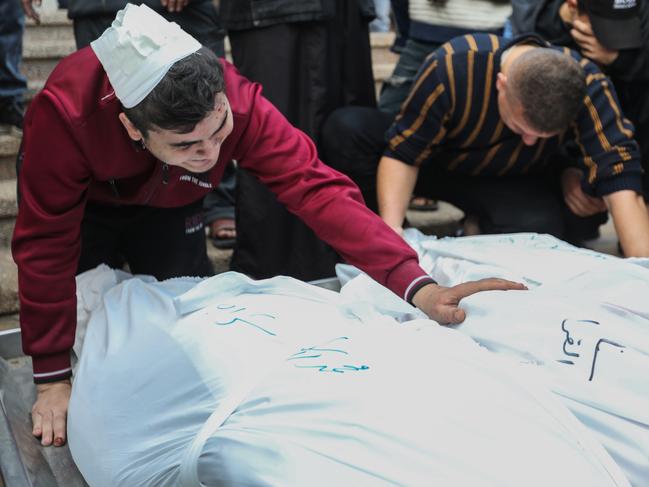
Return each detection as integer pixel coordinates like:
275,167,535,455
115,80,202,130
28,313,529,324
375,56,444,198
323,107,607,243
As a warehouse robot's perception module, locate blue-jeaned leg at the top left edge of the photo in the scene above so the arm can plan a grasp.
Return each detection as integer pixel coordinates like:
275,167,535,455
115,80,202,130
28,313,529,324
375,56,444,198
0,0,27,135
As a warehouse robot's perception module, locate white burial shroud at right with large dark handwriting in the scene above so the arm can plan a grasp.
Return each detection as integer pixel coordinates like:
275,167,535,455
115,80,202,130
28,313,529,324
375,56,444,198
338,229,649,487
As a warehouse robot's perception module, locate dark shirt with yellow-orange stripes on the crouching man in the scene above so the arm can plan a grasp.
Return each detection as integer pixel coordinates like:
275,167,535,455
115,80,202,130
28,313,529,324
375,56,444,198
385,34,642,196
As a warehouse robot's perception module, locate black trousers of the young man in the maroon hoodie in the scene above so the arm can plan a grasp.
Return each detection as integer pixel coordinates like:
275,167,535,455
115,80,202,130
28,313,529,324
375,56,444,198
77,200,214,280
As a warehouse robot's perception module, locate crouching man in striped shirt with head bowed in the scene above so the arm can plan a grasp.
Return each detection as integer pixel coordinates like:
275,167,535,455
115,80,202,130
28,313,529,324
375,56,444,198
324,34,649,256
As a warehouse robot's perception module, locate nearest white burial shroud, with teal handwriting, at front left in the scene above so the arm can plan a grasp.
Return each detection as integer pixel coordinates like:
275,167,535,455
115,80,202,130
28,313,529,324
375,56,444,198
68,268,629,487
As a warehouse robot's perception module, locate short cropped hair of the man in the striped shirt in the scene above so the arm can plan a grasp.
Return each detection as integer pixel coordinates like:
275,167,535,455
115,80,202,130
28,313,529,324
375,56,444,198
507,48,586,134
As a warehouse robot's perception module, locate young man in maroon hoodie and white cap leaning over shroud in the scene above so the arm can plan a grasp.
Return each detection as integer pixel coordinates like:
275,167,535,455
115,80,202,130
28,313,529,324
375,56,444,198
13,5,523,445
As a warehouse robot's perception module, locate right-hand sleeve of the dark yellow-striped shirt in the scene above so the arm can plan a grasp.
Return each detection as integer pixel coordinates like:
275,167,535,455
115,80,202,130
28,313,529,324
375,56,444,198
573,59,642,196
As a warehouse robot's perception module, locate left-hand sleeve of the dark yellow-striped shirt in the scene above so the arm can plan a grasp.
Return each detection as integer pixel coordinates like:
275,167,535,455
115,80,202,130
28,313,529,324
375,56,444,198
384,49,454,166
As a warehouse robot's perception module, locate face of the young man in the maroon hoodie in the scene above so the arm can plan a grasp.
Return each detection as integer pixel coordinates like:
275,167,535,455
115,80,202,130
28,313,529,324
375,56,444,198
122,93,233,173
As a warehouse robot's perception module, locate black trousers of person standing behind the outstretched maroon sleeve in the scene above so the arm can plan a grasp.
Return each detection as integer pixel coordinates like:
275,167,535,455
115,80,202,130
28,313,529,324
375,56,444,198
228,0,376,280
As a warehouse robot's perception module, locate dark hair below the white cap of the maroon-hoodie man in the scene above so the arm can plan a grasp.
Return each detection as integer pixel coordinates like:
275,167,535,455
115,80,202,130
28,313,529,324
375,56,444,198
124,47,225,137
